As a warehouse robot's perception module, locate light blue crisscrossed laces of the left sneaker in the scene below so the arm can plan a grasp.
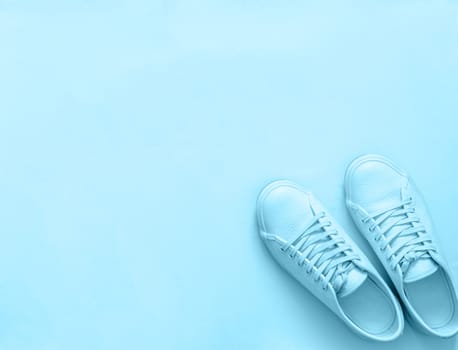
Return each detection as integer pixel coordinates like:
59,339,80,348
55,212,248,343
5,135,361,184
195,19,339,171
281,213,359,293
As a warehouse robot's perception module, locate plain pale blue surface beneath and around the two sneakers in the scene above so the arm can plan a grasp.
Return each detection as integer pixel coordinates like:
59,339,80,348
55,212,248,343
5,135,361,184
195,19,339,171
0,0,458,350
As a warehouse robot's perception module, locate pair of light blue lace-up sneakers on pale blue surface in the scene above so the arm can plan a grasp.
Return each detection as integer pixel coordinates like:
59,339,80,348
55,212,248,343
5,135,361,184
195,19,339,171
257,155,458,341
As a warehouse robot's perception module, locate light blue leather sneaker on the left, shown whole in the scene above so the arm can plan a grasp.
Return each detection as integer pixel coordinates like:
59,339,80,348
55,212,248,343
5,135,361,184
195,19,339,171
257,181,404,341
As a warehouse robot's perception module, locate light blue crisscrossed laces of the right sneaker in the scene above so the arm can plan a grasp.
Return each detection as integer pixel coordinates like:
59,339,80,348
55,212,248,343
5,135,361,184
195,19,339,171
362,197,436,272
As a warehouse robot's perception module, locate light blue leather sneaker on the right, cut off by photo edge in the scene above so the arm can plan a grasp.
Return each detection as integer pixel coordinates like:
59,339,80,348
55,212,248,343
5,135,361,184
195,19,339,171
345,155,458,337
